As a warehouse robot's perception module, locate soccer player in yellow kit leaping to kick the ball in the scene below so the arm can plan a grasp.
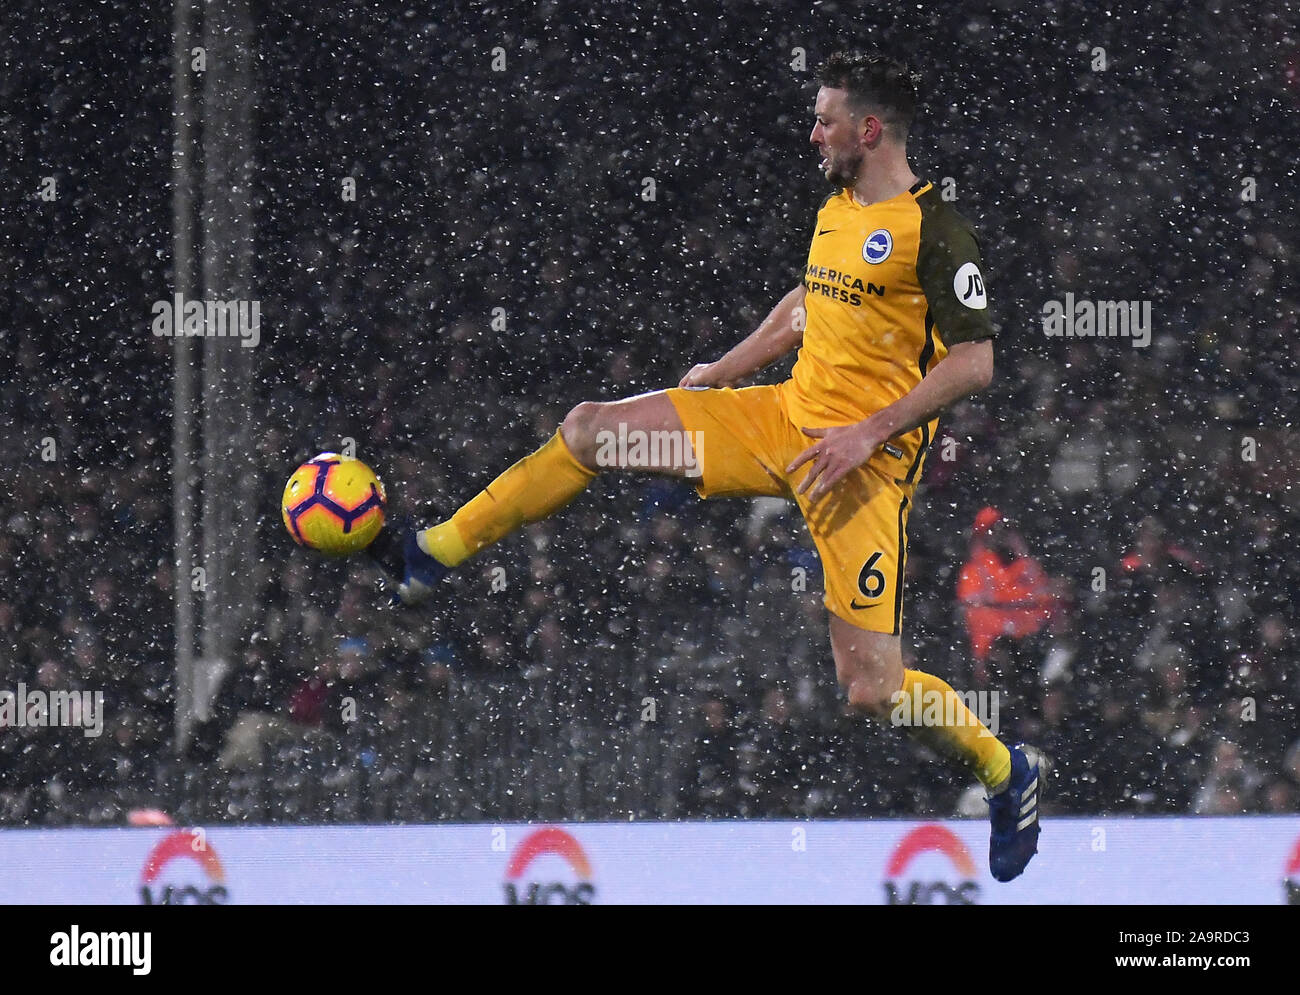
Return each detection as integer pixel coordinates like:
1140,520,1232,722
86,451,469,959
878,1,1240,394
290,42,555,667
374,53,1045,881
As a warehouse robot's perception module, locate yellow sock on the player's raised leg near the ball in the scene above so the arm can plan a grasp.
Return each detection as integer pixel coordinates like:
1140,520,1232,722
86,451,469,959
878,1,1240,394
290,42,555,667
416,432,595,567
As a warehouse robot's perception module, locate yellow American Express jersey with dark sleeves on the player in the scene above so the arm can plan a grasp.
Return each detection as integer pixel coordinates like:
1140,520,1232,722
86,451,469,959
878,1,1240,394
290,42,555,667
783,181,995,484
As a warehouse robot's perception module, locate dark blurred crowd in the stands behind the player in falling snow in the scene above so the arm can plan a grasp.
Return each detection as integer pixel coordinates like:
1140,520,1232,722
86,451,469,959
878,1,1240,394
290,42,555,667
0,3,1300,825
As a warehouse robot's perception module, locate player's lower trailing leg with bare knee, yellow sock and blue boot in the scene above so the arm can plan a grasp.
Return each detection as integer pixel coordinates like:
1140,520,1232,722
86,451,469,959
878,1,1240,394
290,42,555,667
831,615,1047,881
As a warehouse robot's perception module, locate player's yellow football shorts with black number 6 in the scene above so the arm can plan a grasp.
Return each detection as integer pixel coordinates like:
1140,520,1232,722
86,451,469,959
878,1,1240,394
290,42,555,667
666,385,919,635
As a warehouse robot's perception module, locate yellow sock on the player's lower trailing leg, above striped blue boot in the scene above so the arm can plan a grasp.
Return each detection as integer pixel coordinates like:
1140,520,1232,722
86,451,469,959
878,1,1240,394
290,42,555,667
891,670,1011,789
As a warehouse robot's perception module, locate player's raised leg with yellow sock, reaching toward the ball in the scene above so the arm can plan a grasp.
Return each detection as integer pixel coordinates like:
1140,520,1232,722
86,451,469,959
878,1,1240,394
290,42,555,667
372,390,694,605
